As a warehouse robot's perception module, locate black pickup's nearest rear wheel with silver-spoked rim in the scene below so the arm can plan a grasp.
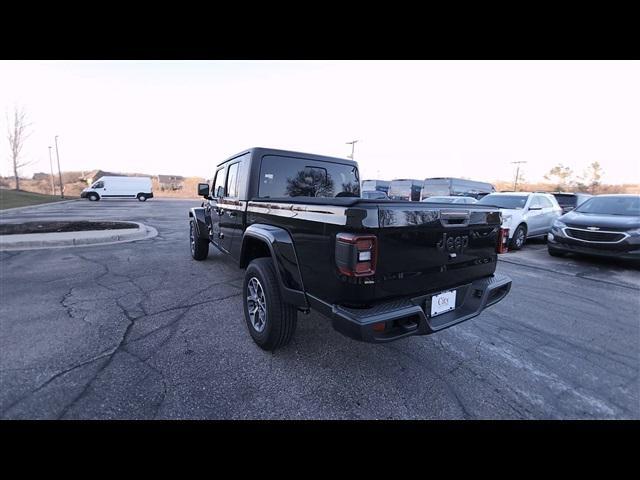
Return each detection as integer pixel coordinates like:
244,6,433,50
242,258,298,350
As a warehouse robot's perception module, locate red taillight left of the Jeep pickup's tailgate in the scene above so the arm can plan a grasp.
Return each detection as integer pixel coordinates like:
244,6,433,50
336,233,378,277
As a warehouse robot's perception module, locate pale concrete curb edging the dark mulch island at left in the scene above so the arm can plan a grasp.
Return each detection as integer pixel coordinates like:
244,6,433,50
0,222,158,251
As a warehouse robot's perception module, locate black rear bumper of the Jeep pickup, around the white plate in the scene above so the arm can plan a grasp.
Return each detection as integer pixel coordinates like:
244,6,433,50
313,275,511,343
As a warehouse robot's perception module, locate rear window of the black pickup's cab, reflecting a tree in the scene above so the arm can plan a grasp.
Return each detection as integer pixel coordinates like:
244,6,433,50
258,155,360,198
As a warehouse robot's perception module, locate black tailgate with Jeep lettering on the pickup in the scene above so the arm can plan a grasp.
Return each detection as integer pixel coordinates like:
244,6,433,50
376,203,501,298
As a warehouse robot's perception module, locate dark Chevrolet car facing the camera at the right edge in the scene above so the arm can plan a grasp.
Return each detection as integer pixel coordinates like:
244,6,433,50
547,195,640,261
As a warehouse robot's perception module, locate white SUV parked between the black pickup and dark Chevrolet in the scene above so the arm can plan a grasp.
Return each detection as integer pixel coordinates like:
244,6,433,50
478,192,562,250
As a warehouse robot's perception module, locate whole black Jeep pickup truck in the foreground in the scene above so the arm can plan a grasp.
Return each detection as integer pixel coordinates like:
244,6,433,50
189,148,511,350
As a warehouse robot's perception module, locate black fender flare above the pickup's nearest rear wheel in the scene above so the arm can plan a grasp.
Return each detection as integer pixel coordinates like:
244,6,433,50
240,223,309,309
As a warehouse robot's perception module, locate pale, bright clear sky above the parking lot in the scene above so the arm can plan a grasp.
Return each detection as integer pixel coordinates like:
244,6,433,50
0,61,640,183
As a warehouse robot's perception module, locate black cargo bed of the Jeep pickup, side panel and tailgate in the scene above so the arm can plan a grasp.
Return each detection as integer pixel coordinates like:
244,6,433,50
247,197,501,306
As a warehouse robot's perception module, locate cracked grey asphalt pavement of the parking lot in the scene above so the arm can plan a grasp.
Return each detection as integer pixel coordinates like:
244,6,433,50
0,199,640,419
